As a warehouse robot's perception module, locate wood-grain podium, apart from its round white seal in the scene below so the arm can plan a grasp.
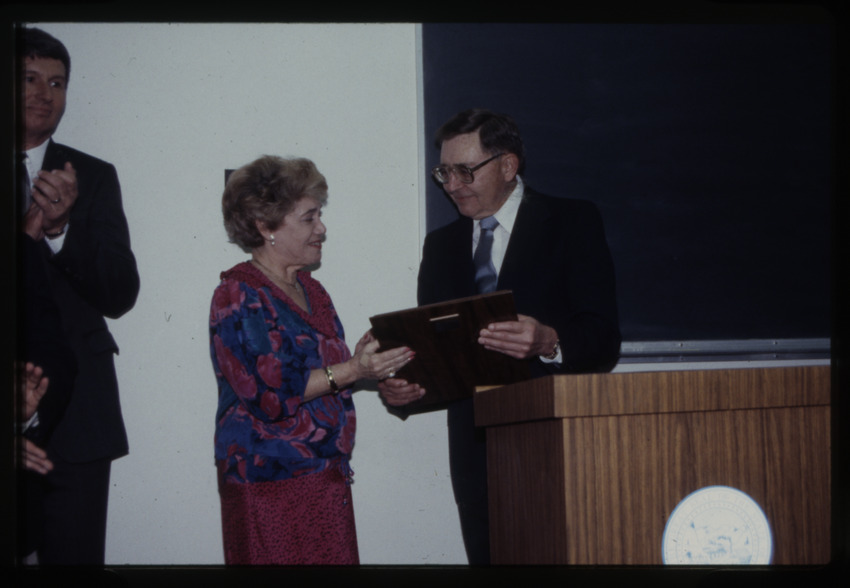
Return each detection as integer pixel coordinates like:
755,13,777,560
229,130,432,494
474,366,831,565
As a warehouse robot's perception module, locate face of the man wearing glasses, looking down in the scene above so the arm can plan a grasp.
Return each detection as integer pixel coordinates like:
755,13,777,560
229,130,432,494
440,131,516,219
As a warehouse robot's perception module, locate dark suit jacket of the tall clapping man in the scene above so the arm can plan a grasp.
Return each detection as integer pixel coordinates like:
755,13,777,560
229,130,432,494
37,140,139,462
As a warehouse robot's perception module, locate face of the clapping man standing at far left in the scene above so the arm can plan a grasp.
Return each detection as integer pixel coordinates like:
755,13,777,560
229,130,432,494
23,57,68,149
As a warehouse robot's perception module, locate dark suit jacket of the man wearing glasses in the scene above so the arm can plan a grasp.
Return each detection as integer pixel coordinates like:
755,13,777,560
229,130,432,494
418,188,620,376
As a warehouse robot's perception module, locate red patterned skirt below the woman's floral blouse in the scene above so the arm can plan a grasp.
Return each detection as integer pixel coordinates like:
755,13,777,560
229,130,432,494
218,467,360,565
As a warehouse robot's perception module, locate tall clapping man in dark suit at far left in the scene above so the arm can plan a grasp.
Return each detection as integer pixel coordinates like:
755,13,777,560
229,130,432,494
19,28,139,565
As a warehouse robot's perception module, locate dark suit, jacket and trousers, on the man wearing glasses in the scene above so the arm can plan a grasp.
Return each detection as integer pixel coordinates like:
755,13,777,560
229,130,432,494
418,188,620,548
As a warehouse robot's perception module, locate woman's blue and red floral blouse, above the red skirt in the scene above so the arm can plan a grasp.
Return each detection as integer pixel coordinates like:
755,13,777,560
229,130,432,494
210,262,356,483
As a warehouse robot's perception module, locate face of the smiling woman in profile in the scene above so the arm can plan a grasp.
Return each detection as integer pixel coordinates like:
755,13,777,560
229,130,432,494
271,197,327,267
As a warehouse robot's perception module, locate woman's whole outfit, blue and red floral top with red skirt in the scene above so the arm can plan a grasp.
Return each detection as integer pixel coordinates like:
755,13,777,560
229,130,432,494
210,262,357,564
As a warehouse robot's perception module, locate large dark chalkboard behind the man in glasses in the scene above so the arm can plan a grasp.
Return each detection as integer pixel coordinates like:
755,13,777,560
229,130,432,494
422,23,835,356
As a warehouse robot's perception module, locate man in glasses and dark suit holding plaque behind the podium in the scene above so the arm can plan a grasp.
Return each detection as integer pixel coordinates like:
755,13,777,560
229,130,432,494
379,109,621,565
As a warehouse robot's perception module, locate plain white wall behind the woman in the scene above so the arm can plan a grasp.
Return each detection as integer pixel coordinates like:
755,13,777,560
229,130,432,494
36,23,466,565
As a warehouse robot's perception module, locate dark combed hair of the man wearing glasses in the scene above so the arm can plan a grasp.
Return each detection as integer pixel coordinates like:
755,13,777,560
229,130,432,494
435,108,525,173
